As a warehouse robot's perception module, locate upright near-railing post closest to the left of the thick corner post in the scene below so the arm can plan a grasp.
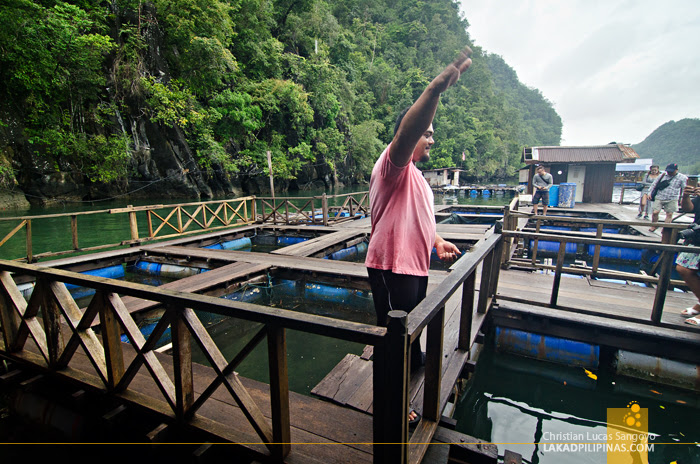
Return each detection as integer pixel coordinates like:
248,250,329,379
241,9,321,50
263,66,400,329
267,325,292,462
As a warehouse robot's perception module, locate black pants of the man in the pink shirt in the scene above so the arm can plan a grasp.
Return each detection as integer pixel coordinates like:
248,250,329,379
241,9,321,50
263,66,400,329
367,267,428,371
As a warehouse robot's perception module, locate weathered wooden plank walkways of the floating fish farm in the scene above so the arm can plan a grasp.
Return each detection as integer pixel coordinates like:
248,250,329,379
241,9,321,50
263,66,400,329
0,200,700,464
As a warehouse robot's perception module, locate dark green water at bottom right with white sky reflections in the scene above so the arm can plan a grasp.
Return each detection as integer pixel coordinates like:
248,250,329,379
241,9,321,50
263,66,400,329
454,342,700,464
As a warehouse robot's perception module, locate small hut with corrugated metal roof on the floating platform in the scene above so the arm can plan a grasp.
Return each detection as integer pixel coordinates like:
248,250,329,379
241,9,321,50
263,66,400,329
522,143,639,203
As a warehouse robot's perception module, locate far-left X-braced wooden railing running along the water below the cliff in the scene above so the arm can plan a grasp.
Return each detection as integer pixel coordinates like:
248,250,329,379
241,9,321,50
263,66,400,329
0,197,255,263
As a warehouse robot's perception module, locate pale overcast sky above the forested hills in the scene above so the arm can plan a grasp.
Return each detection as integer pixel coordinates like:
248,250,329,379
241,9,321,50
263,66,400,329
460,0,700,145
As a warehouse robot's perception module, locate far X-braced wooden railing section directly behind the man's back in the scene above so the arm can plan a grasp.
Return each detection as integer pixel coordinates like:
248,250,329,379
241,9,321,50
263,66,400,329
256,192,369,226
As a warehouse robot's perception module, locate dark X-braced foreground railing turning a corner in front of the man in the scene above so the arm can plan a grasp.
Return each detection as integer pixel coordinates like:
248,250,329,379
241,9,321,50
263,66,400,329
0,229,502,463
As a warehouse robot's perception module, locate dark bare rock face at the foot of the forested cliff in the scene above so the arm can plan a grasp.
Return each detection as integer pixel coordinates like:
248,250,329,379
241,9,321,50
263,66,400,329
0,4,340,207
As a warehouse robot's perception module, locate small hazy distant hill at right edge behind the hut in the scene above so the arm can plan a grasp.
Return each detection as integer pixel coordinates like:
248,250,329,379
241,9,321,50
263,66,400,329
632,119,700,174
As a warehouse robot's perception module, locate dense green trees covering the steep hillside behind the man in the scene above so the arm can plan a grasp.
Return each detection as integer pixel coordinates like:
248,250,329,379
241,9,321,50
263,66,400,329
0,0,561,193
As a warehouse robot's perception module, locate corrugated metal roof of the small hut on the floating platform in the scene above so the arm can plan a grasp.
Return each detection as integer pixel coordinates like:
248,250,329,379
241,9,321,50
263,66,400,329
522,143,639,164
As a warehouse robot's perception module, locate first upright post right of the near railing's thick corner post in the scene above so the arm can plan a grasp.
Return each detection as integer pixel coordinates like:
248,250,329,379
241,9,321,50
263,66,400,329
423,306,445,422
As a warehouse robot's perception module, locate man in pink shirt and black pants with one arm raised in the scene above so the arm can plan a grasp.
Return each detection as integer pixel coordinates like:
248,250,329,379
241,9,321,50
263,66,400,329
365,48,472,421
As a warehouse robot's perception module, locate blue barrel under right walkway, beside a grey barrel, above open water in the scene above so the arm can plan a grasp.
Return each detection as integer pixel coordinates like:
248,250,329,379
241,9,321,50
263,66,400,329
496,327,600,368
